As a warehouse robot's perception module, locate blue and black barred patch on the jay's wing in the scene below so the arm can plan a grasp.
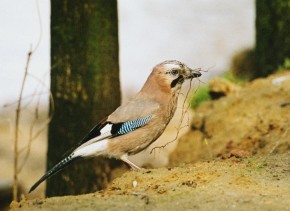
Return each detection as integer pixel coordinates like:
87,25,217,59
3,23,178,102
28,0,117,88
116,114,153,135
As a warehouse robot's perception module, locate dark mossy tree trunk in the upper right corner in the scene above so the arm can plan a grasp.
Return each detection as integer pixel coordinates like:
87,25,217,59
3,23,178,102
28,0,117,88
255,0,290,77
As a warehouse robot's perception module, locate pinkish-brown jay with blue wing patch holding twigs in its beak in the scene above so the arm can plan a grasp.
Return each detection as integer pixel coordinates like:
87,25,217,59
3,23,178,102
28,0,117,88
29,60,201,193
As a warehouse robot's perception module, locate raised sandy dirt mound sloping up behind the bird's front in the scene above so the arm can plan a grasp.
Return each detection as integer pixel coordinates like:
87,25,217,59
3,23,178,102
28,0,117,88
171,72,290,165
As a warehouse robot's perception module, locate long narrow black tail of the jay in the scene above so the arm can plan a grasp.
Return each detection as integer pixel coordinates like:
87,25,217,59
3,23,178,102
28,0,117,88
29,155,79,193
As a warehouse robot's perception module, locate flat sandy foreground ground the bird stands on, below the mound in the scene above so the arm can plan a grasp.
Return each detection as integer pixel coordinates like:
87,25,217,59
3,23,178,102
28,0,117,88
12,155,290,210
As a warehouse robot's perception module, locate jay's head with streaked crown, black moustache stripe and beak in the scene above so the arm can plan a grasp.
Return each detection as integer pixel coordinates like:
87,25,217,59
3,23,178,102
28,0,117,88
151,60,201,92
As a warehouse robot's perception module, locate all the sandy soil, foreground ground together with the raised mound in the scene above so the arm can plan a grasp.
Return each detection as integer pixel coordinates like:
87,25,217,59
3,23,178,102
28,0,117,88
10,71,290,210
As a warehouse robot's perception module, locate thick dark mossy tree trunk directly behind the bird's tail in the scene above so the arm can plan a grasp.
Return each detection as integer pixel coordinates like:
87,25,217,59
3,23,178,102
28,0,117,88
46,0,120,196
